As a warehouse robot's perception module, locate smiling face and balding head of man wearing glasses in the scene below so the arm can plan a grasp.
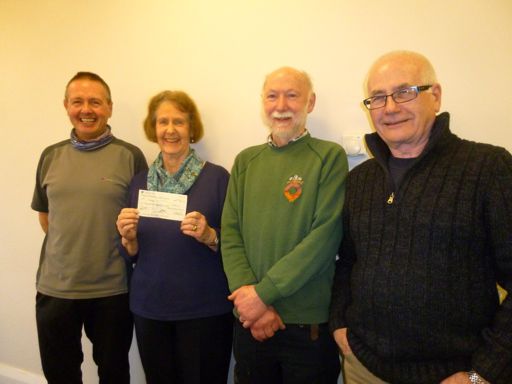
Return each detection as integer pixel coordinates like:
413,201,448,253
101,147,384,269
367,55,441,157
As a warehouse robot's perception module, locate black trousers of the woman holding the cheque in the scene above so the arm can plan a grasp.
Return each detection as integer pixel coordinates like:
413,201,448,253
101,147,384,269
134,312,233,384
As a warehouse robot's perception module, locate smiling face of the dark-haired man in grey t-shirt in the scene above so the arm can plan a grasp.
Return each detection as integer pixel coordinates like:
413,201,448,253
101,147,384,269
64,79,112,141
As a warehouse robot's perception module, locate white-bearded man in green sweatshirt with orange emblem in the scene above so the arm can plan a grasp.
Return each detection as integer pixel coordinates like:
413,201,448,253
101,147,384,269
221,67,348,384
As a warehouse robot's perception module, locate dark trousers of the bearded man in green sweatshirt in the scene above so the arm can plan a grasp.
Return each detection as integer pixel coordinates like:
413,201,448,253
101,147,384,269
233,321,341,384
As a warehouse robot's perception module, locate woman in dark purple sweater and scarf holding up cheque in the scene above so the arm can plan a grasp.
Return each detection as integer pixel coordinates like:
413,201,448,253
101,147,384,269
117,91,233,384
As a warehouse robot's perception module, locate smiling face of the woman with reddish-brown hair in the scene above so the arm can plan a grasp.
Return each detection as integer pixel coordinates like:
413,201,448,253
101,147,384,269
155,101,190,172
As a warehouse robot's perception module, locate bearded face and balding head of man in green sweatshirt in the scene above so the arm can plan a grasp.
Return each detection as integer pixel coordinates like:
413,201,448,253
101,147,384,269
262,68,315,146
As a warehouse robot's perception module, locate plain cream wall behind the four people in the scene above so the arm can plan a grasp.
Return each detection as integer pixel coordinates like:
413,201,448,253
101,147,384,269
0,0,512,383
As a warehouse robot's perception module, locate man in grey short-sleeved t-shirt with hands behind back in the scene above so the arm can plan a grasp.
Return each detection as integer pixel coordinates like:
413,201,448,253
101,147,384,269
32,72,147,384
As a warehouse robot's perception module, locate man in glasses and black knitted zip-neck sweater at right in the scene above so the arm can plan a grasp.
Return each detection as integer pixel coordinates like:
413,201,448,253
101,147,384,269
330,51,512,384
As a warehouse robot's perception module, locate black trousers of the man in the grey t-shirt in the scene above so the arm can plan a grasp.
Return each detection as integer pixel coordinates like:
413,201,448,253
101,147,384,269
36,293,133,384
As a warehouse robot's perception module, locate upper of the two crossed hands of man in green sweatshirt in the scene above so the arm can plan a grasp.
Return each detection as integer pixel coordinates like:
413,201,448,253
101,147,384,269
228,285,268,328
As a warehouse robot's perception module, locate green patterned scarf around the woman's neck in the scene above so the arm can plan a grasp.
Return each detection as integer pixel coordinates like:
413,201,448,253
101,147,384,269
148,149,205,195
